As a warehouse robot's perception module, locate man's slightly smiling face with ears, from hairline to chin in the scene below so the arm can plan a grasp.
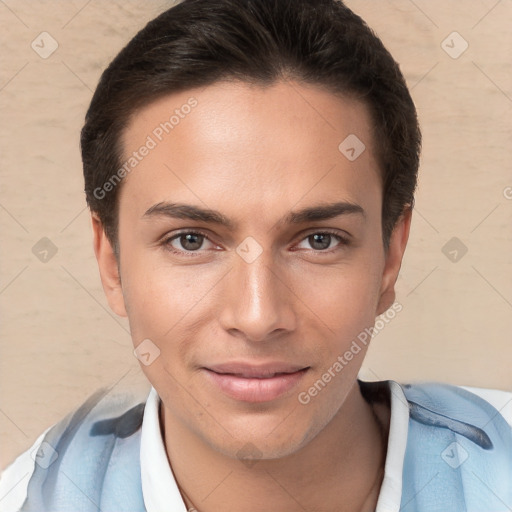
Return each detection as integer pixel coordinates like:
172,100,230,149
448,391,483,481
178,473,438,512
93,82,408,458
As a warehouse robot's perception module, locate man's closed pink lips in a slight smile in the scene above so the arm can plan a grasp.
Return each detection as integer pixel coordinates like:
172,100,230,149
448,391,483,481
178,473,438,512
203,363,309,403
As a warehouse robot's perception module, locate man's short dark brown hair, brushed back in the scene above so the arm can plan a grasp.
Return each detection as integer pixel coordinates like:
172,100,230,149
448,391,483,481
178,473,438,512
80,0,421,248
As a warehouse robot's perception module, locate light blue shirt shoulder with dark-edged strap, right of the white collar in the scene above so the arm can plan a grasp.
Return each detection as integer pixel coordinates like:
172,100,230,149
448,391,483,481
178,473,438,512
401,382,512,512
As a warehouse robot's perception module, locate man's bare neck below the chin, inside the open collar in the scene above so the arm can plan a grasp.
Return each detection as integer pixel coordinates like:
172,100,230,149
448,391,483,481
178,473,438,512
161,382,389,512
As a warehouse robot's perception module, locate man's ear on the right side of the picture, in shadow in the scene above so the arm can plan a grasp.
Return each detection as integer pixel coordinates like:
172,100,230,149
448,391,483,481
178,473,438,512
376,207,412,315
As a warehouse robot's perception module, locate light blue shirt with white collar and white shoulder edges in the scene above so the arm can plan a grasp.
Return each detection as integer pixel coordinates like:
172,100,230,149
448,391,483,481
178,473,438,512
0,380,512,512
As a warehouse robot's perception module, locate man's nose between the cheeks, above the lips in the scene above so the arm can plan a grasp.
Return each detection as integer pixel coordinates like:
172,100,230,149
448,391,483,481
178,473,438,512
220,245,297,342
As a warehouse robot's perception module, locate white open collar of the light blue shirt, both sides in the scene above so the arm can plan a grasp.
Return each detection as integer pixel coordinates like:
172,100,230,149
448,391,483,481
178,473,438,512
140,380,409,512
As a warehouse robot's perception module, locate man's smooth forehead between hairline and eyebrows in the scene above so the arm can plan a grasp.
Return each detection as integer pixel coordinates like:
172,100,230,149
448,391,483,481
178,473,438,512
117,82,380,222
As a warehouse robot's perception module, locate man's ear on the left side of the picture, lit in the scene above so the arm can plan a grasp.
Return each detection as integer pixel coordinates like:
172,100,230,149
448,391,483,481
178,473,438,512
91,213,128,316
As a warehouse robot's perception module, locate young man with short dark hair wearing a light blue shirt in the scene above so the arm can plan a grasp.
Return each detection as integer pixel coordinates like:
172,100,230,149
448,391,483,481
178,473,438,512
0,0,512,512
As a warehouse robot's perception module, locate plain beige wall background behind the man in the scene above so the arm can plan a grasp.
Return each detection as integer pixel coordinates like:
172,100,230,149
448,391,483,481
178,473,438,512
0,0,512,467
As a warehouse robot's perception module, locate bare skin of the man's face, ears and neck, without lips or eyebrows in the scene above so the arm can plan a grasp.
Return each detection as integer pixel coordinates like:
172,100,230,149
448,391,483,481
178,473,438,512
92,81,411,512
